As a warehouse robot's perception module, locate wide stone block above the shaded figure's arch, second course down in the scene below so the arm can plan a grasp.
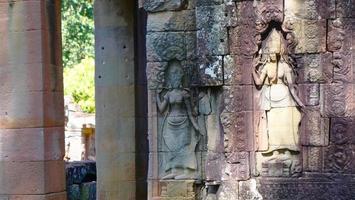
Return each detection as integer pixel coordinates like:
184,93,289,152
147,10,196,32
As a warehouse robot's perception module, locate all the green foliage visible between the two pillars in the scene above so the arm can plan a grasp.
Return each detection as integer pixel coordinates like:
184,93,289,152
62,0,95,113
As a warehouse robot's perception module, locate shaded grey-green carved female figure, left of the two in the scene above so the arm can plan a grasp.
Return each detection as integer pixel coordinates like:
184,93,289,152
156,61,200,180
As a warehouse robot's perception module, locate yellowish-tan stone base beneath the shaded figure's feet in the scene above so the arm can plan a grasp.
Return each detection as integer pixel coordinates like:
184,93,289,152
152,180,197,200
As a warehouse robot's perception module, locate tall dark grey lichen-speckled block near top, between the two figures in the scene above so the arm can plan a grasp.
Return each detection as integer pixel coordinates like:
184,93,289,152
196,5,228,57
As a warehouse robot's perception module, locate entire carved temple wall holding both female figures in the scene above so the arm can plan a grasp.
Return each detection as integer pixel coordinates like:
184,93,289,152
142,0,355,200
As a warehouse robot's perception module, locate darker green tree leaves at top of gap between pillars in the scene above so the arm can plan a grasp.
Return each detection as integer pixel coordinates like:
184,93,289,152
62,0,94,68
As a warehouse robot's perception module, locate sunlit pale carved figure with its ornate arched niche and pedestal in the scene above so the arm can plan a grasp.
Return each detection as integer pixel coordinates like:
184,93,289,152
252,4,304,177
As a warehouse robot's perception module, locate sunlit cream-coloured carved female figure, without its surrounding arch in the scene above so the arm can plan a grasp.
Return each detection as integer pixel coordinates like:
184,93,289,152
252,27,304,175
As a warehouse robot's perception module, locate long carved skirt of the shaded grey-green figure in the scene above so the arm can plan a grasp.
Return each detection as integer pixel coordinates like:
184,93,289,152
163,116,197,171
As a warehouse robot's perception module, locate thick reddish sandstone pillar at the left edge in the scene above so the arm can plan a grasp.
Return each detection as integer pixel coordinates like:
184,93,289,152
0,0,66,200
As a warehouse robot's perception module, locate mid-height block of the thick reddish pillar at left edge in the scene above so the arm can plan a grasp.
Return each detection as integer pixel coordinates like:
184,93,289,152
0,92,64,128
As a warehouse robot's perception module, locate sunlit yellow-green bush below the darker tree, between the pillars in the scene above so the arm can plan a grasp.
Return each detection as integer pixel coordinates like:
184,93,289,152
64,58,95,113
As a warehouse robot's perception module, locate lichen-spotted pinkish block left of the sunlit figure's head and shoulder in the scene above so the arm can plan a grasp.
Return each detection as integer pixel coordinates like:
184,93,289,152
223,55,253,85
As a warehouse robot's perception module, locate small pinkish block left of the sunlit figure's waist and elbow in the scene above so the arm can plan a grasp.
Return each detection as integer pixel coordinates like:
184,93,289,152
223,85,253,113
